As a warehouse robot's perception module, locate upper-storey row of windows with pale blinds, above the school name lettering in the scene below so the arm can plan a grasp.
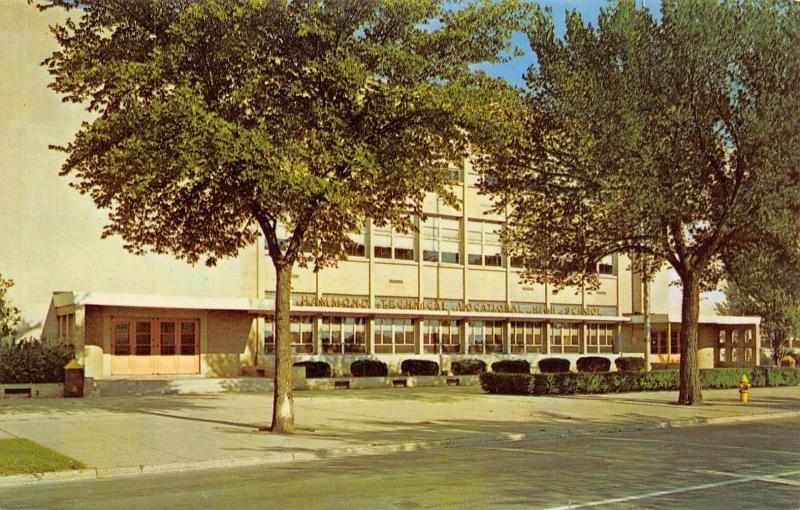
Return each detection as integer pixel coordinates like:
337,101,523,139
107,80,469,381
277,216,614,274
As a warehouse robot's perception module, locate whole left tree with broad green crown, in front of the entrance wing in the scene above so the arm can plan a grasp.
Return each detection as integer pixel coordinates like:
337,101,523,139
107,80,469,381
41,0,525,433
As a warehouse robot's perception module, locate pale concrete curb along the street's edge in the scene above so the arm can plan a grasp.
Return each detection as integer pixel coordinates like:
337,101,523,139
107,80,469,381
0,411,800,488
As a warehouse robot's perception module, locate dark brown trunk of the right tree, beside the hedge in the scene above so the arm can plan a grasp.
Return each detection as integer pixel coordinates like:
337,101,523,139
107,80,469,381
678,274,703,406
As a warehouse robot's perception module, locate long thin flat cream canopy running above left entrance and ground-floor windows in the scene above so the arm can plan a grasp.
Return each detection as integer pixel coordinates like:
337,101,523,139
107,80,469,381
53,291,631,322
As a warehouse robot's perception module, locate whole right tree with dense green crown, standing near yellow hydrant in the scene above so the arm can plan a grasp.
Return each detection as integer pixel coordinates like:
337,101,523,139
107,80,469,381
478,0,800,405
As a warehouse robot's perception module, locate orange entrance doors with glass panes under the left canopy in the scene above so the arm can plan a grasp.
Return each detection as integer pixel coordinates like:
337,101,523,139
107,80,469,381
111,318,200,375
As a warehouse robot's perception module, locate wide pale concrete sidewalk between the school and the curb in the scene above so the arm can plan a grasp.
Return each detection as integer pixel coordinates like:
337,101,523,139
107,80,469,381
0,387,800,486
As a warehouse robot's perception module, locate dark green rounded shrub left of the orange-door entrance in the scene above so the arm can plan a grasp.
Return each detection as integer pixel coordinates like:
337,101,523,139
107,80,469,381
0,338,74,384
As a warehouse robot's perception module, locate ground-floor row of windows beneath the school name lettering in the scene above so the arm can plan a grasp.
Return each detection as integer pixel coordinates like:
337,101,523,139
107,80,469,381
264,316,617,354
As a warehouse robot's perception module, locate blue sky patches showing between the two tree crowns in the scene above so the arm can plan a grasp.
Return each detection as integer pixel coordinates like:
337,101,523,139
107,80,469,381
479,0,661,86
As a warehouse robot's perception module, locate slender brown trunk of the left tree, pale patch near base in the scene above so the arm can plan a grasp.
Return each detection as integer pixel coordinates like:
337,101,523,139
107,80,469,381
272,263,294,434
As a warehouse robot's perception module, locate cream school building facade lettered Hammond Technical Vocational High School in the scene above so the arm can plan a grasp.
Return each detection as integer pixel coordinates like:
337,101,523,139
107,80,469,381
0,1,759,378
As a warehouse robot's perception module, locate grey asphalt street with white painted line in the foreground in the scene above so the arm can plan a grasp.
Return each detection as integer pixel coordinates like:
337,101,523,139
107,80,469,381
0,419,800,510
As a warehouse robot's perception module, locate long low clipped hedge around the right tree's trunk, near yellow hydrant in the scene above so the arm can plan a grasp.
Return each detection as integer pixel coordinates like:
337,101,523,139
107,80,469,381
481,367,800,395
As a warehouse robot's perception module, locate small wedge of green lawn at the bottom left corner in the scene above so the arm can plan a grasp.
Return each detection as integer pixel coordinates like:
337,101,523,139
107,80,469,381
0,438,86,476
